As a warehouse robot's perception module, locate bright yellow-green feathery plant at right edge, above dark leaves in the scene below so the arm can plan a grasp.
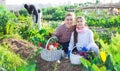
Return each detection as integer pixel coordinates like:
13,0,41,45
100,34,120,64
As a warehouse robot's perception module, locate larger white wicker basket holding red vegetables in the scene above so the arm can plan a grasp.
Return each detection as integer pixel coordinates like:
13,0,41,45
41,37,62,61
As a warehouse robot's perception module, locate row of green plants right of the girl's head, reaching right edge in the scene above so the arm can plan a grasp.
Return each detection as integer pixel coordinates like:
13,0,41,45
85,16,120,28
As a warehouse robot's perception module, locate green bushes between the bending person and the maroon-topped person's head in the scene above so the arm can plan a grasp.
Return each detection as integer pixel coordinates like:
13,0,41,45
42,7,67,21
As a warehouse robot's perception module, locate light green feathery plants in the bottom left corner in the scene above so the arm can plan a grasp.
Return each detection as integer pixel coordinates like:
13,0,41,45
0,45,27,71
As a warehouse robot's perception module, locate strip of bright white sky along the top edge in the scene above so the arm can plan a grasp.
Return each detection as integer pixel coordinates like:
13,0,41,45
6,0,120,5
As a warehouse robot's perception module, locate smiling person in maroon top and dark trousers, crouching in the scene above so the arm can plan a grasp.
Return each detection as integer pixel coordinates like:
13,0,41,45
53,13,74,58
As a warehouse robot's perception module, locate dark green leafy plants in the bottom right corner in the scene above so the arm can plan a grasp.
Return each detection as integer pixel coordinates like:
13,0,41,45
80,55,120,71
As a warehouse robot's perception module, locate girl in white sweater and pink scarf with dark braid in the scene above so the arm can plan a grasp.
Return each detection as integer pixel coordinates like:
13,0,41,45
69,16,99,55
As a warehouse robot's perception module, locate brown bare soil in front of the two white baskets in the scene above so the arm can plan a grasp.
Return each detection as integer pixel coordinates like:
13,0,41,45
36,55,83,71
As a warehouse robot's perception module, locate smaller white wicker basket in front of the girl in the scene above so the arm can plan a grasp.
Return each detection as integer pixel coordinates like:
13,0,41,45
70,46,82,64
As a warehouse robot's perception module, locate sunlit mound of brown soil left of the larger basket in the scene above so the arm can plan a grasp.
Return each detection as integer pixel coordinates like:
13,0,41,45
0,38,37,59
